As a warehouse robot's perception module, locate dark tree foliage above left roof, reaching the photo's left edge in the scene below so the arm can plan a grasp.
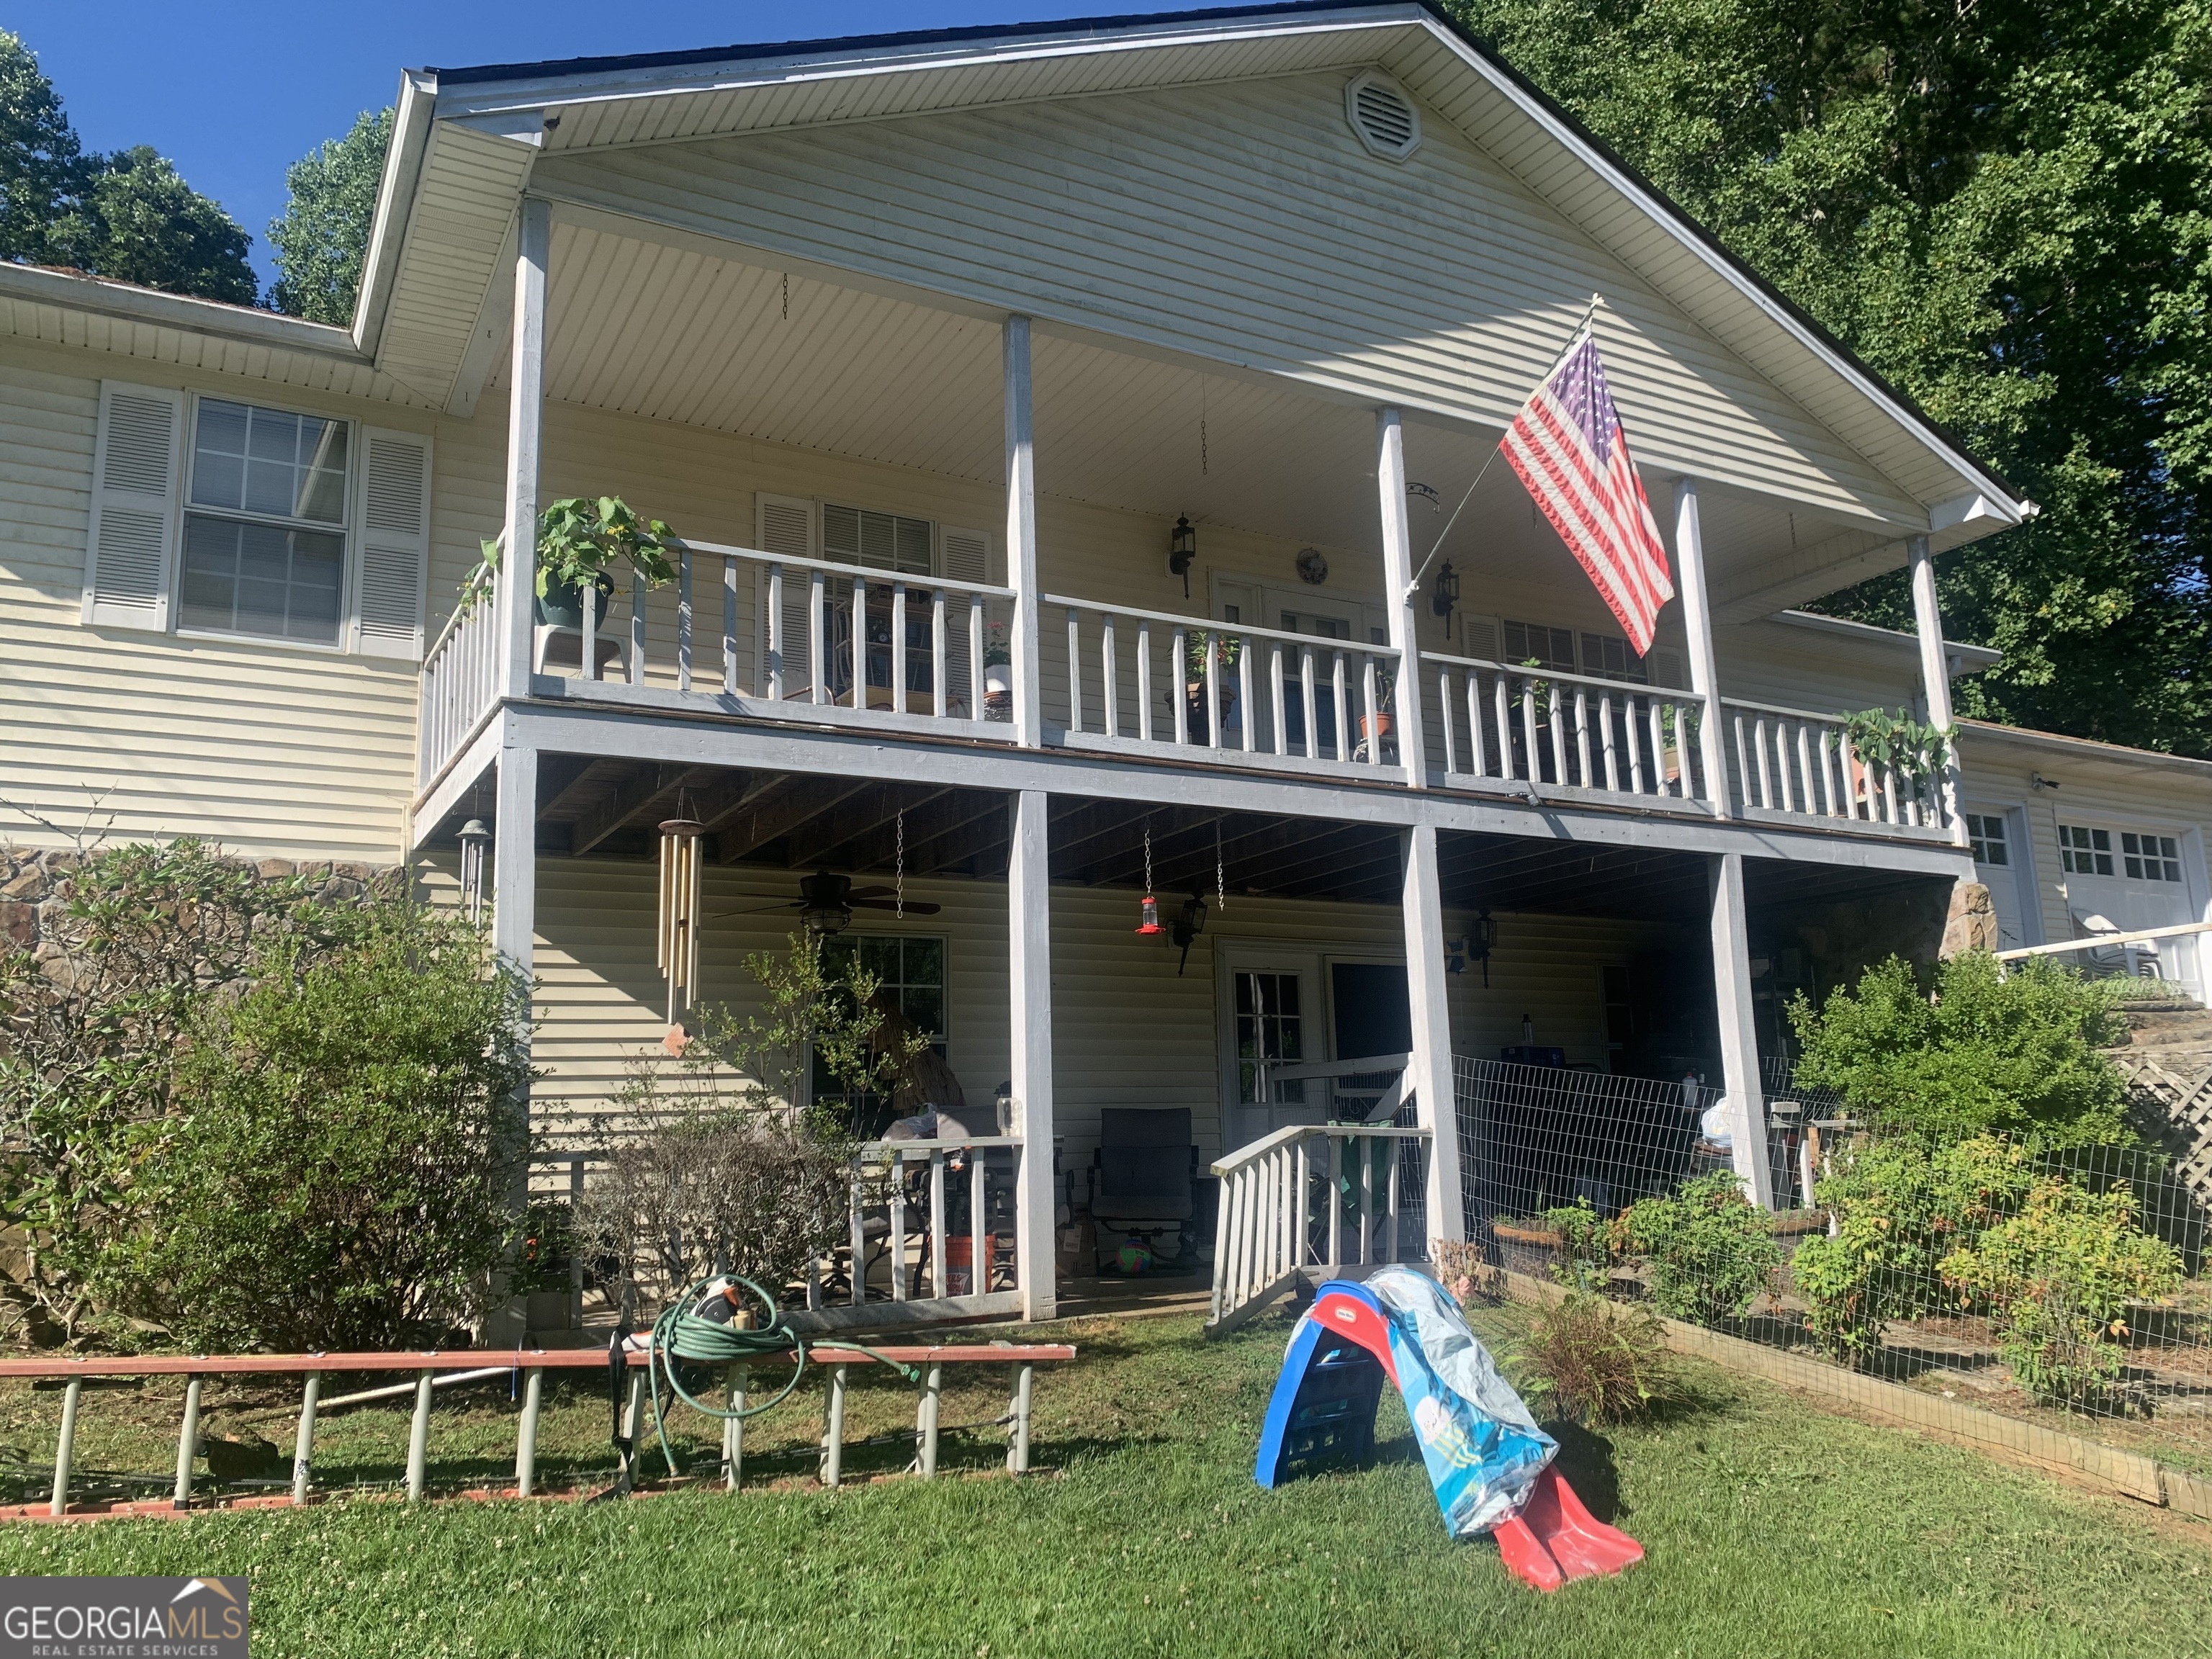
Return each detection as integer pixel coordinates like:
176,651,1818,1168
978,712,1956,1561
0,31,258,305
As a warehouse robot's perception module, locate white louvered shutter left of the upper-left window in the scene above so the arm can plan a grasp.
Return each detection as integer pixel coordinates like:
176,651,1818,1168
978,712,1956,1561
84,380,184,628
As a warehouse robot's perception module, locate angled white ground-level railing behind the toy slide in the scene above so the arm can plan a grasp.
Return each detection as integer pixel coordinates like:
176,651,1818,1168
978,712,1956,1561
1205,1124,1429,1336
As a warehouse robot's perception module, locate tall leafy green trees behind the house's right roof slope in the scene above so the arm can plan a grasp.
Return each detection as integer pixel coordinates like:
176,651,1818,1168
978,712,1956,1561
1453,0,2212,755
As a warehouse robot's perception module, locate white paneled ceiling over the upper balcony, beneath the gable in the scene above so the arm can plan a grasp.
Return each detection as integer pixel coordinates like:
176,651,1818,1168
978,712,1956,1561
526,221,1887,611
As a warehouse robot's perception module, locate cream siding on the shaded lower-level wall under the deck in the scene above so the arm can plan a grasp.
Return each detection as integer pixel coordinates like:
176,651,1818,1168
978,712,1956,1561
488,860,1648,1170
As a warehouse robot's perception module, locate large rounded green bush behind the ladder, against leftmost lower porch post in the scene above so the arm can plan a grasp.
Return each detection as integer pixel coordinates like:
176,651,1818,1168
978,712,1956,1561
93,894,529,1349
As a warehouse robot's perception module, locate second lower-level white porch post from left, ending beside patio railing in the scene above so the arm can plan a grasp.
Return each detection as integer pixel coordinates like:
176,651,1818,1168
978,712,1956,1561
1007,790,1055,1318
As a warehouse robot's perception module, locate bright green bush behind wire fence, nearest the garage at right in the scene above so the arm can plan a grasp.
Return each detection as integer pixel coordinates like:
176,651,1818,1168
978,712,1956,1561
1789,951,2126,1146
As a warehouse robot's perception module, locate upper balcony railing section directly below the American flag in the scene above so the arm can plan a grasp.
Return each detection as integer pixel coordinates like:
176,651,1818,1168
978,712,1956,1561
1420,652,1712,801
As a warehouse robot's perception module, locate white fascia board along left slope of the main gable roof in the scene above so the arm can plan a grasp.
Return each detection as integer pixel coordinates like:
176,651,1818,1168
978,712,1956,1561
420,4,1429,117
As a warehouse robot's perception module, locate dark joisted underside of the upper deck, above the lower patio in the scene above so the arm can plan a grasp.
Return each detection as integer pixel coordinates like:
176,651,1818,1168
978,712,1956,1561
480,755,1927,925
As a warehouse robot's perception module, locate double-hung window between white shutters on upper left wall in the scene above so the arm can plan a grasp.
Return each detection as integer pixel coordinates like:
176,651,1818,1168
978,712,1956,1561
177,398,351,646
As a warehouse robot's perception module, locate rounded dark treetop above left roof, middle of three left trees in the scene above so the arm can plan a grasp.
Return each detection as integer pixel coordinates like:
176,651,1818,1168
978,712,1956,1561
47,144,258,305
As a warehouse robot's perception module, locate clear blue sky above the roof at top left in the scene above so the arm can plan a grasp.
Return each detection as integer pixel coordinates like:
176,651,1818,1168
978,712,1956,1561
13,0,1123,285
